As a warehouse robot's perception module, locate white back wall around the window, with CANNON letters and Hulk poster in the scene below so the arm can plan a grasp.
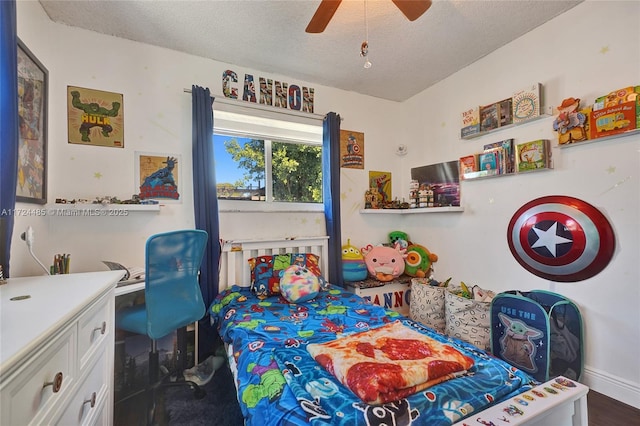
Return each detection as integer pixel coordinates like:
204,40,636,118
11,1,401,276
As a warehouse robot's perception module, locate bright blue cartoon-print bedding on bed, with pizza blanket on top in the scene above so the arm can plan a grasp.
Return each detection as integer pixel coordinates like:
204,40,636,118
209,285,535,426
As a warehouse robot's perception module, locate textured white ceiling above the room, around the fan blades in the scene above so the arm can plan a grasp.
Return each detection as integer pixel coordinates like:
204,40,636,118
40,0,582,101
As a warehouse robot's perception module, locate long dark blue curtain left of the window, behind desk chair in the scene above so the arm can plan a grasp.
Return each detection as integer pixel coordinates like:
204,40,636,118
191,86,221,360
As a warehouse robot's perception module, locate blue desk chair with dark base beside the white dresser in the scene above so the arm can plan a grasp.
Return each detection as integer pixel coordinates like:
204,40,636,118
116,229,208,423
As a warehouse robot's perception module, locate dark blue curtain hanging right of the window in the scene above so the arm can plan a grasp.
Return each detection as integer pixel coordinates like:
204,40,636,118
322,112,344,286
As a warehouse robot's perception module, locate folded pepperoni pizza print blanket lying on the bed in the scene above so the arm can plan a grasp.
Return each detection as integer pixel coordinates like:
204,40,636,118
307,321,473,405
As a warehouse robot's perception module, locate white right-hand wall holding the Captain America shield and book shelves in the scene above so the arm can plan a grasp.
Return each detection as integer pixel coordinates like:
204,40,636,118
398,1,640,407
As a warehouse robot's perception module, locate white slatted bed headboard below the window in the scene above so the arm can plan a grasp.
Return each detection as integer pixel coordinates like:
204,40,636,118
219,236,329,291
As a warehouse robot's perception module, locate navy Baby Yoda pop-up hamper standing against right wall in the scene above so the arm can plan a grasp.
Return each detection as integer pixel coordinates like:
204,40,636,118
491,290,583,382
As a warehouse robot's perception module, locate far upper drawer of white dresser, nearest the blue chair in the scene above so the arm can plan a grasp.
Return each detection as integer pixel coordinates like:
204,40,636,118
78,297,114,374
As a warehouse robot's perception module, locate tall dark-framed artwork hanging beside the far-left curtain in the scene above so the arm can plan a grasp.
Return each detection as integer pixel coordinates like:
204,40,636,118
16,39,49,204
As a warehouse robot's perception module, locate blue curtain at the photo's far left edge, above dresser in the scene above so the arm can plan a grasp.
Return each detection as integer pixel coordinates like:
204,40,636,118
0,0,18,278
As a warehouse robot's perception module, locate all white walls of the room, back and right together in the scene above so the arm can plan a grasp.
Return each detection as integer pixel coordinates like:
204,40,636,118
11,1,640,407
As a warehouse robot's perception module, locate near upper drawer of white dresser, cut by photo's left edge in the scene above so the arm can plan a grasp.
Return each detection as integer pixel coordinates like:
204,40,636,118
0,324,77,425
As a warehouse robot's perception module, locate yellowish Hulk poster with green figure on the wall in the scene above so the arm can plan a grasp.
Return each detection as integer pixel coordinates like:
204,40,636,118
67,86,124,148
